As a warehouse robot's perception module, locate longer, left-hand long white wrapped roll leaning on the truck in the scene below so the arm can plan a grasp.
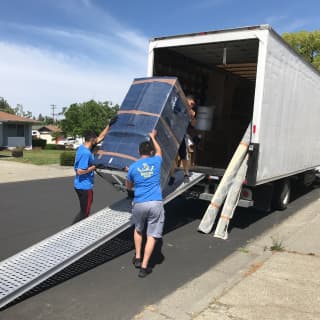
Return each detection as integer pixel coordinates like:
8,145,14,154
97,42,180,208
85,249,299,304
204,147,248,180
198,123,251,233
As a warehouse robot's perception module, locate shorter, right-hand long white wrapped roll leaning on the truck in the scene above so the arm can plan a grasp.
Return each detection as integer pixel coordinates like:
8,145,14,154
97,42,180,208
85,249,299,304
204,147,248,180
214,154,249,240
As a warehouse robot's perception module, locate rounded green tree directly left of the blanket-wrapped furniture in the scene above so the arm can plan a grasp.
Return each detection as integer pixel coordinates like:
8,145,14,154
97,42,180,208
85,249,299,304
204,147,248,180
61,100,119,137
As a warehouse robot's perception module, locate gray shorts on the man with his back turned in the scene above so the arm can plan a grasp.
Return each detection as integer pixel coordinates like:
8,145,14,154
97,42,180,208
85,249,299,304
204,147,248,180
132,201,164,238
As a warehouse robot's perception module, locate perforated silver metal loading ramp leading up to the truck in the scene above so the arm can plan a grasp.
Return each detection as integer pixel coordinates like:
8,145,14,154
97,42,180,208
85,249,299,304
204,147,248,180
0,172,204,308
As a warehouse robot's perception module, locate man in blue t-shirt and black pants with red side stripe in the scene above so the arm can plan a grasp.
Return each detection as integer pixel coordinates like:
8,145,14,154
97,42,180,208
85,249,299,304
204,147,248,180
74,118,116,223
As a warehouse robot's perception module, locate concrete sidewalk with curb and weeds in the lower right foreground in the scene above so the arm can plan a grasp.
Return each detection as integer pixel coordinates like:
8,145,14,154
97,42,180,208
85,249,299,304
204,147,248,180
134,190,320,320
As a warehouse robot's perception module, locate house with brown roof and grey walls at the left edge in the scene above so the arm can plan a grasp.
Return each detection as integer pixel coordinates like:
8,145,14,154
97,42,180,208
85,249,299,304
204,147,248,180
0,111,38,148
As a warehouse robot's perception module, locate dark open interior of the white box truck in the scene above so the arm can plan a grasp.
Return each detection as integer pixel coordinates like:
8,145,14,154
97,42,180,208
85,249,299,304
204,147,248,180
153,48,255,169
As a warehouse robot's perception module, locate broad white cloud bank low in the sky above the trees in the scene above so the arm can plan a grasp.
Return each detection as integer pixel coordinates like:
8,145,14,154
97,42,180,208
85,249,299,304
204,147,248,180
0,42,145,115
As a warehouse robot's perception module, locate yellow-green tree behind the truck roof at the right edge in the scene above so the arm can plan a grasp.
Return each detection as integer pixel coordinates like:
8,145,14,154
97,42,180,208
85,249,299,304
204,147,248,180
282,30,320,69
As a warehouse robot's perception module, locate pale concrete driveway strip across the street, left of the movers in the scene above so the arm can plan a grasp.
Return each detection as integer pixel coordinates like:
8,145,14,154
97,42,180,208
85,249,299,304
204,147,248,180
0,160,74,184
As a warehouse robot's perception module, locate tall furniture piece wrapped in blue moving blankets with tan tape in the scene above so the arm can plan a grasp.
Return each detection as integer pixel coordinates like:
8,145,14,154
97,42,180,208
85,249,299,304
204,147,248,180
95,77,189,188
